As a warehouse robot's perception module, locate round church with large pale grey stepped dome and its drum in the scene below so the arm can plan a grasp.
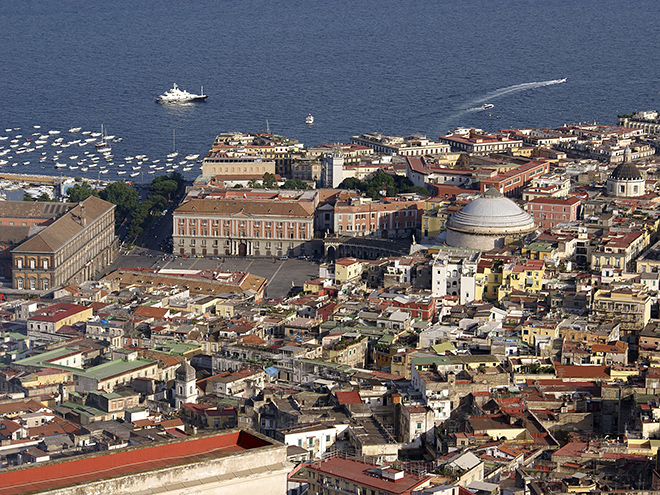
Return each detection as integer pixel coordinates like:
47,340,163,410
446,188,536,251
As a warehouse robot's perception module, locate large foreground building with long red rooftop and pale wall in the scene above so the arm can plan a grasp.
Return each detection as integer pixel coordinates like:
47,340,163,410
0,430,291,495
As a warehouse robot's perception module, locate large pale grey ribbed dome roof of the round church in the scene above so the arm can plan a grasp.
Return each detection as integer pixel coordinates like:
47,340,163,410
448,188,536,235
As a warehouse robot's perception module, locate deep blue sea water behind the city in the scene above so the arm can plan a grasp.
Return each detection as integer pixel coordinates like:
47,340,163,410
0,0,660,181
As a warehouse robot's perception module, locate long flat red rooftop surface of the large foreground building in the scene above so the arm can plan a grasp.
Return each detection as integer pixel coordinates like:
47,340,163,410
0,431,275,495
